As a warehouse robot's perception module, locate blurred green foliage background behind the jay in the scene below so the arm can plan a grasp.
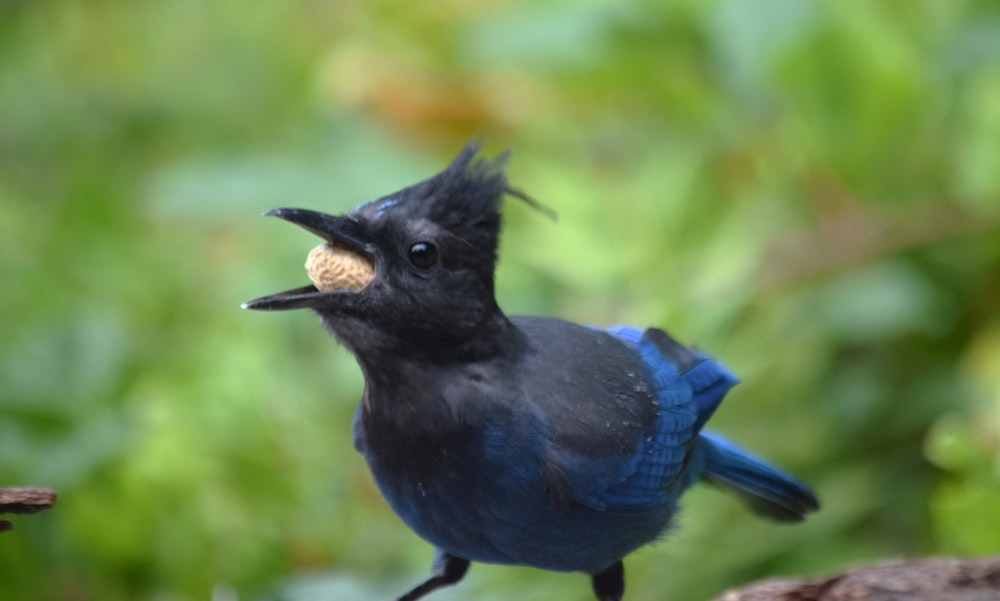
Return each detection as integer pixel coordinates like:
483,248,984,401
0,0,1000,601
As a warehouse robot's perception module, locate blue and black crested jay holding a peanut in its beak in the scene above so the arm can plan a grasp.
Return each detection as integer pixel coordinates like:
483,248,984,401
243,140,819,601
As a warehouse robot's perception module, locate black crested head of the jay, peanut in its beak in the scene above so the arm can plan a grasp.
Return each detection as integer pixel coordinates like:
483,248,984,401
243,143,550,353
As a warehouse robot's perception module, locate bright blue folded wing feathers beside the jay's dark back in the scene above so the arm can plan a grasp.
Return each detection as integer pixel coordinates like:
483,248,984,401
581,326,738,512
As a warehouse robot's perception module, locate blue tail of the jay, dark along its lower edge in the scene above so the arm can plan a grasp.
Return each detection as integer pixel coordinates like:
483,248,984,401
698,431,819,522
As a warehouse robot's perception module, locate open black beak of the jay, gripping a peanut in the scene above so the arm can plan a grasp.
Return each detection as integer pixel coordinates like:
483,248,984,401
242,209,374,311
